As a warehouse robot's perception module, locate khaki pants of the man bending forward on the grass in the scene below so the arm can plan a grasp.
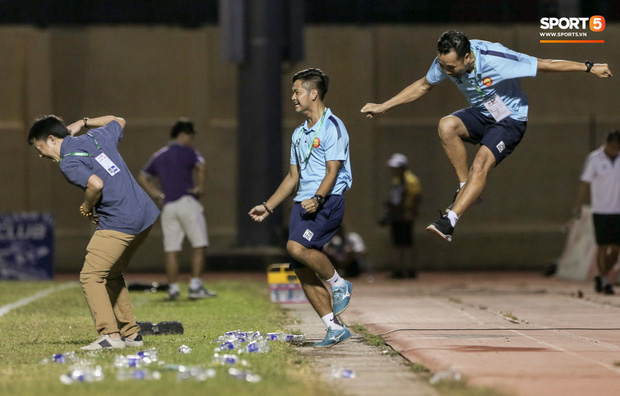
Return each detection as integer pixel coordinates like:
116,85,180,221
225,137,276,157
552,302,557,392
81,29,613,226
80,226,152,337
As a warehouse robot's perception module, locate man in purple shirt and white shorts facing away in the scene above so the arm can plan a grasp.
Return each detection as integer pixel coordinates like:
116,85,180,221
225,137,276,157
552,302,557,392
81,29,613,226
138,119,216,300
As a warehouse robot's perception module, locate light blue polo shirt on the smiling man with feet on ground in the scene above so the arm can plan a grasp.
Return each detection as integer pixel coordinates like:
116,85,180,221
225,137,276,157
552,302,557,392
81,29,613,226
291,108,353,202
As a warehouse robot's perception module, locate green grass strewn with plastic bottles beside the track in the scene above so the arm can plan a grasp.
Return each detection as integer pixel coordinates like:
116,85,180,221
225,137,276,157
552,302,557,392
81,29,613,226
0,280,335,396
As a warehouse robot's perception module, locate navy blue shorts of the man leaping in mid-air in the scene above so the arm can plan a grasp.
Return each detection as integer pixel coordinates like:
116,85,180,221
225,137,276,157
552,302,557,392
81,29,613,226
452,107,527,165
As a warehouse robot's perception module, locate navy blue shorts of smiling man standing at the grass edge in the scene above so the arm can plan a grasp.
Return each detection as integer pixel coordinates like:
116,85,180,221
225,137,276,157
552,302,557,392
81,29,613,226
288,195,344,269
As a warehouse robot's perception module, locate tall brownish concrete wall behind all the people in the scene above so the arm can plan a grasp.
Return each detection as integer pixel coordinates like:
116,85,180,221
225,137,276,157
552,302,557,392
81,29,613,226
0,25,620,270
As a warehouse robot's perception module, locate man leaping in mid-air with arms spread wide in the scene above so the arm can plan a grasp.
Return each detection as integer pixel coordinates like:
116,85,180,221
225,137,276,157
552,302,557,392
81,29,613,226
361,30,612,242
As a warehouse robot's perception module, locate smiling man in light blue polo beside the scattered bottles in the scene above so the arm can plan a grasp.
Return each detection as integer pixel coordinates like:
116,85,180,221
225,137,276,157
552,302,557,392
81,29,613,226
249,69,353,347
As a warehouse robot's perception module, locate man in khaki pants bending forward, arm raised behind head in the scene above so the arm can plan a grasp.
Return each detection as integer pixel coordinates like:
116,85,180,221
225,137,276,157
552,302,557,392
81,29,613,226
28,115,159,350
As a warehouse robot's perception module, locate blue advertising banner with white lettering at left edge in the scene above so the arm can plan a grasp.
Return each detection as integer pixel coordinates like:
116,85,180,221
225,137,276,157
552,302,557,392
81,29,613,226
0,212,54,280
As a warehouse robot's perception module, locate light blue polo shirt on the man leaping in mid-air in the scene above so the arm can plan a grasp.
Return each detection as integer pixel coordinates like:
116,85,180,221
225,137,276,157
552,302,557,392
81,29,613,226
426,40,538,121
